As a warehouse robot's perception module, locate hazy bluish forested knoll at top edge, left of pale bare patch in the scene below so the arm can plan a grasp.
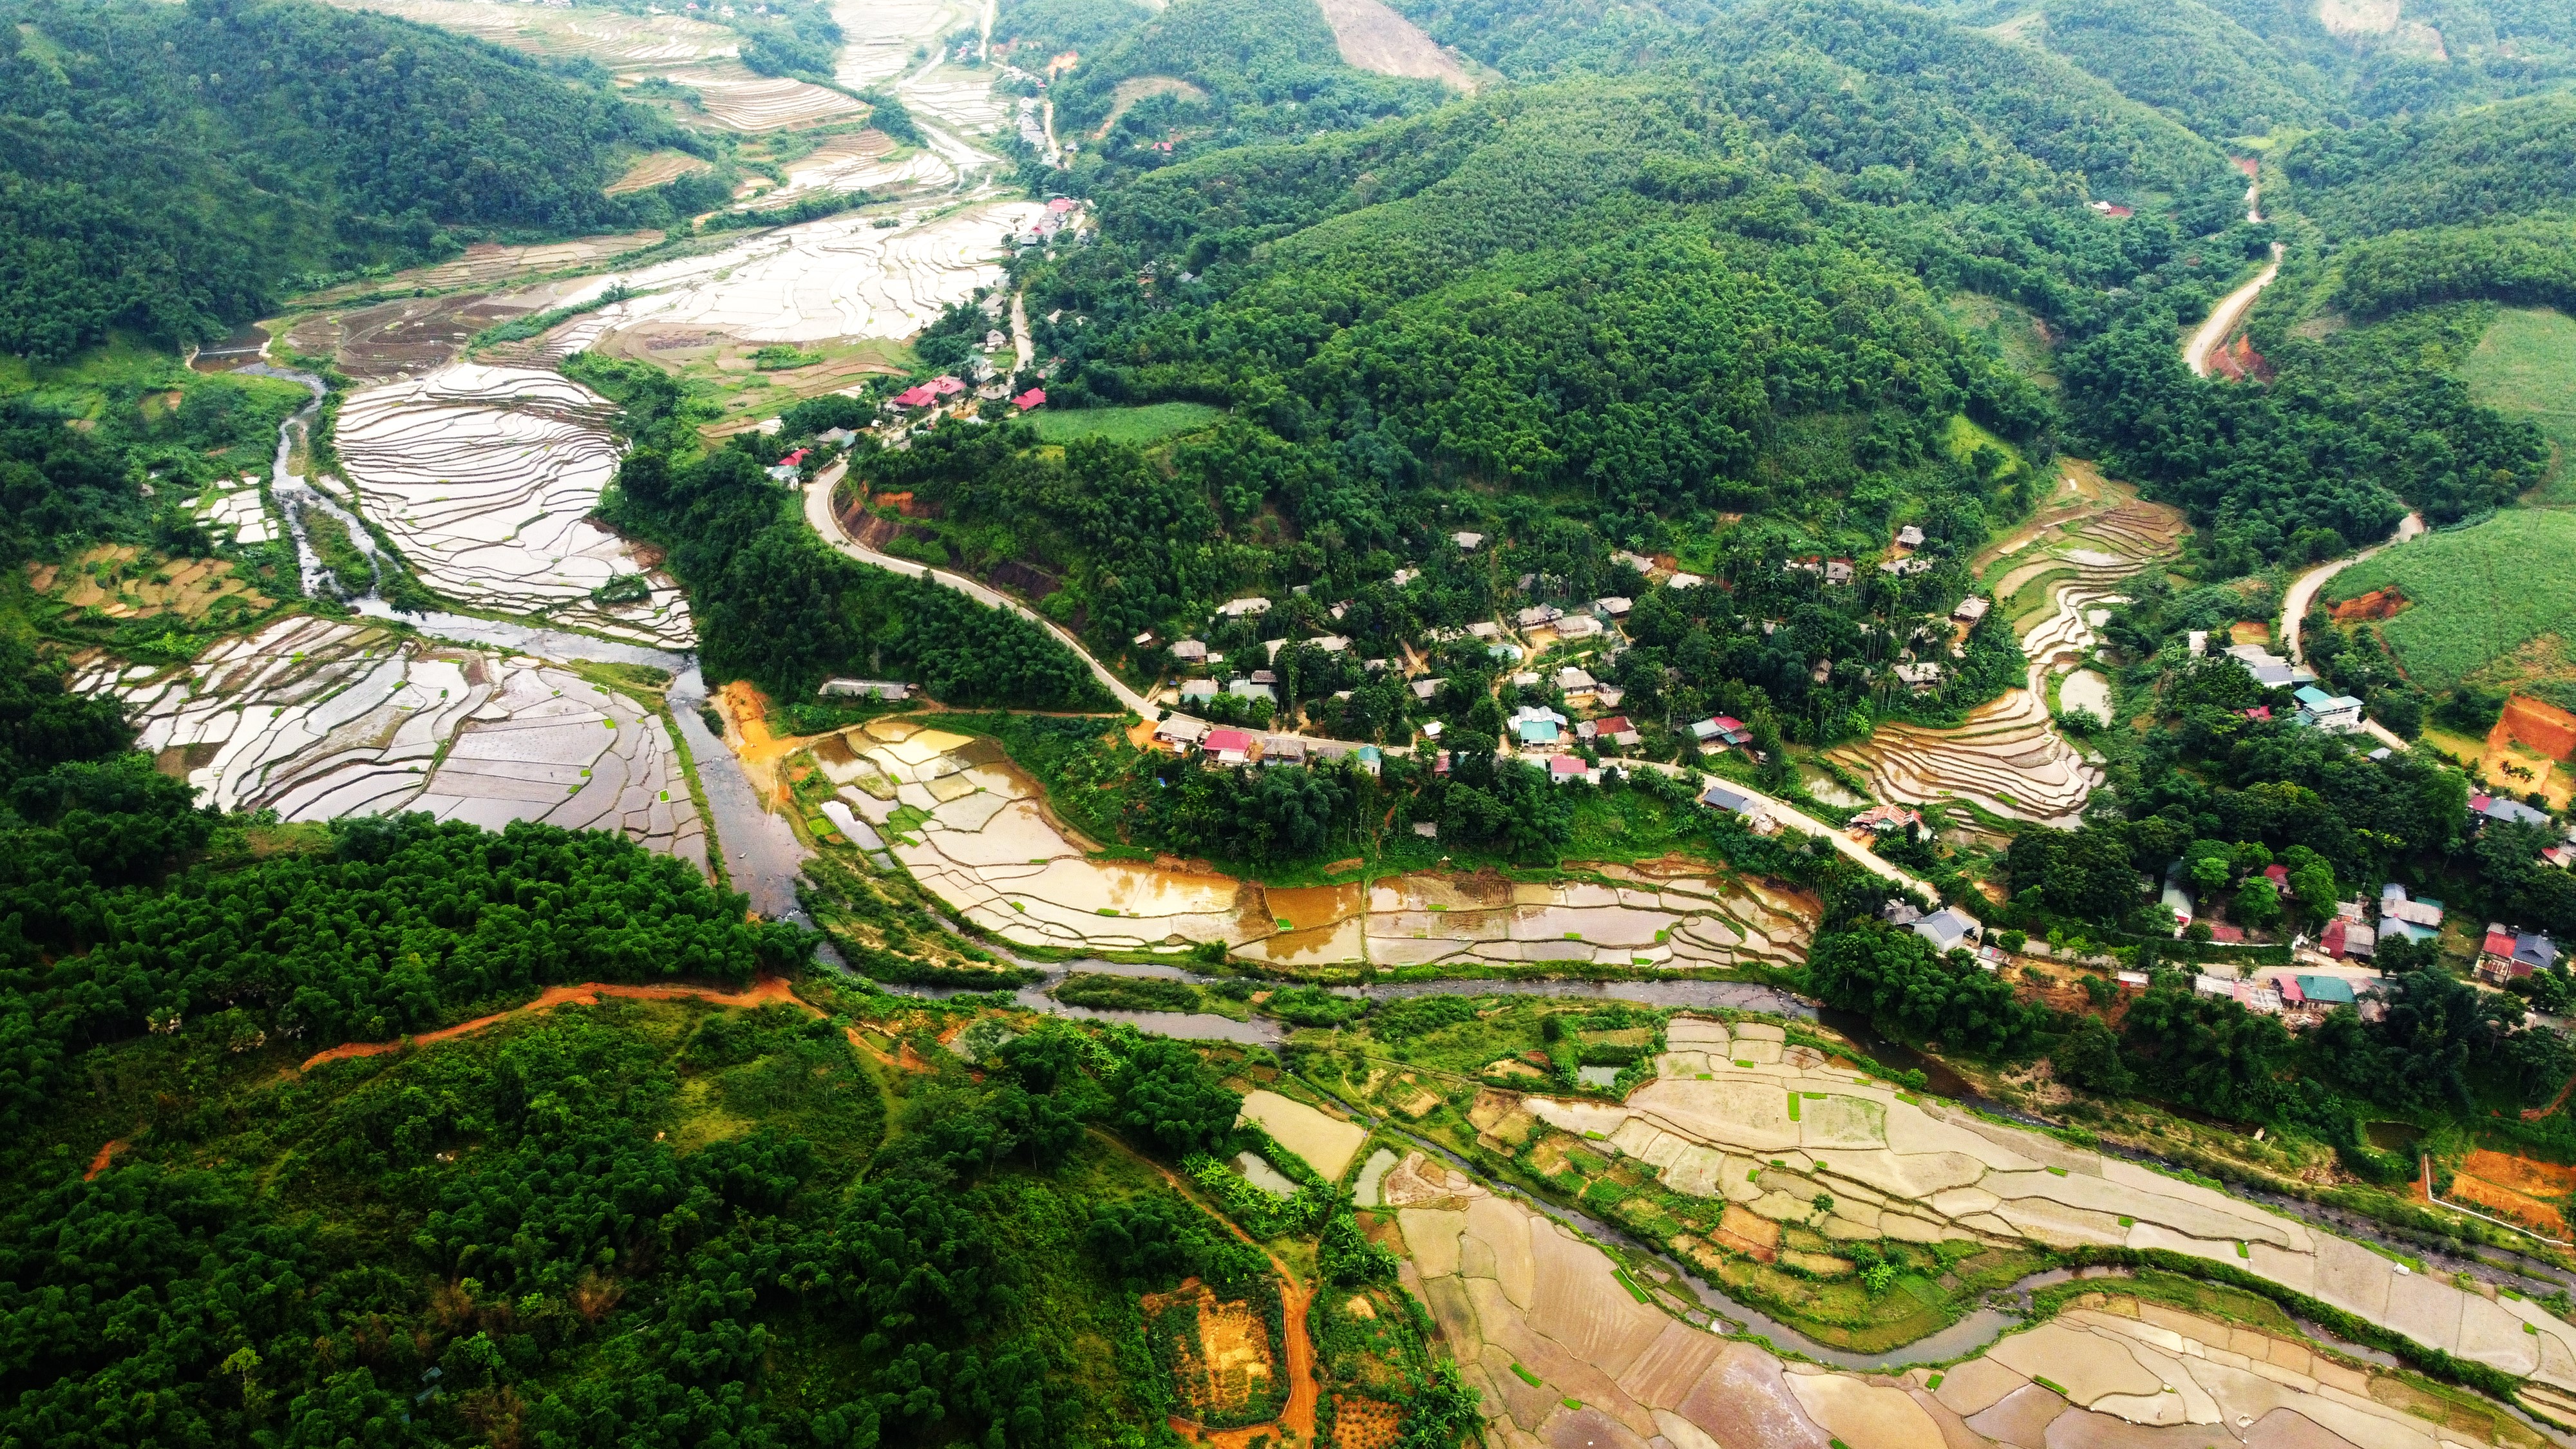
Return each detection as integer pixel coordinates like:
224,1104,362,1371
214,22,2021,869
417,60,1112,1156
2040,0,2318,137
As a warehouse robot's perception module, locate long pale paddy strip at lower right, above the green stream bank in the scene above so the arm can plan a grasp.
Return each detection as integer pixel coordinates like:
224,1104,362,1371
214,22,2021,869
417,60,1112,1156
1484,1016,2576,1413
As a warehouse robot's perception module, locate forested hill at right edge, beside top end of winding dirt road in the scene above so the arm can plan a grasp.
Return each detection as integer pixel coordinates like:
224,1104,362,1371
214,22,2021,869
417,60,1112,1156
2282,93,2576,240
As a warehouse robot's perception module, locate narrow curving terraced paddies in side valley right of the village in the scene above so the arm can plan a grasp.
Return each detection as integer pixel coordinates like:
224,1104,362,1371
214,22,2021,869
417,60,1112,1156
1832,493,2184,825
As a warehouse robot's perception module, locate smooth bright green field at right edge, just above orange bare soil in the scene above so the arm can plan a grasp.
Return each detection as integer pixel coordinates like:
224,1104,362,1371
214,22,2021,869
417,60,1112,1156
2326,508,2576,688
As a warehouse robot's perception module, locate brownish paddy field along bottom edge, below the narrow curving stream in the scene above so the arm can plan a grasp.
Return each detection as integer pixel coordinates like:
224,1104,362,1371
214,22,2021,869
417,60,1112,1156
1388,1153,2532,1449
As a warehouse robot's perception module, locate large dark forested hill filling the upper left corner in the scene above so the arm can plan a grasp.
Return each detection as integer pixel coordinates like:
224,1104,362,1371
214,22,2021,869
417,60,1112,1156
0,0,693,358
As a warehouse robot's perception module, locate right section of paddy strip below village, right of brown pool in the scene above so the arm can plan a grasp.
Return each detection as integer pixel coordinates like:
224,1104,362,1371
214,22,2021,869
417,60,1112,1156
1368,864,1808,967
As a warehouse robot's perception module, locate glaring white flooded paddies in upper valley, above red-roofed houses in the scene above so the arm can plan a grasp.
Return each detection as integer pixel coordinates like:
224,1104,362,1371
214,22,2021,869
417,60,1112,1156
544,201,1043,355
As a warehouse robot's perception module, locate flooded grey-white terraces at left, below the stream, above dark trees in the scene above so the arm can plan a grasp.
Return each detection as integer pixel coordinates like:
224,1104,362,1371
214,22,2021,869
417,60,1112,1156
72,616,706,869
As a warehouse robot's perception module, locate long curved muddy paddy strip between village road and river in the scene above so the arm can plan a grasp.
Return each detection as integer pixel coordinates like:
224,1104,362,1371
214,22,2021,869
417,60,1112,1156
783,717,1816,980
